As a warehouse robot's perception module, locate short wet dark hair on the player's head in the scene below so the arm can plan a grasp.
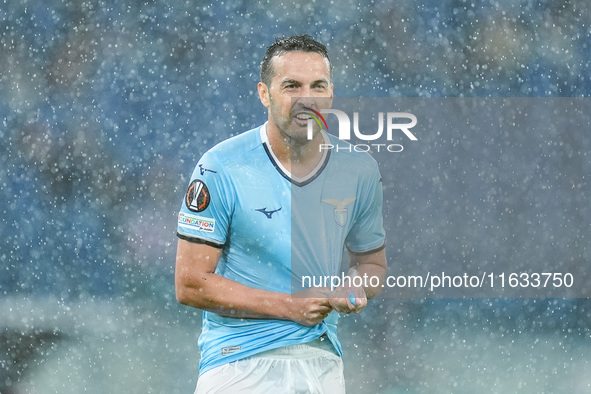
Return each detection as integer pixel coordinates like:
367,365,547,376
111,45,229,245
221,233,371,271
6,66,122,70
261,34,332,86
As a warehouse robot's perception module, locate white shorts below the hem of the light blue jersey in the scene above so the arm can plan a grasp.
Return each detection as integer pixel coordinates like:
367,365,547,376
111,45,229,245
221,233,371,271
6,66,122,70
195,339,345,394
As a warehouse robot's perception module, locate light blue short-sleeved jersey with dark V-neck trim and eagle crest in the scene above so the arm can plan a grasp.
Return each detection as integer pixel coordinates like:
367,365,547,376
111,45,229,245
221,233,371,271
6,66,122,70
178,125,385,374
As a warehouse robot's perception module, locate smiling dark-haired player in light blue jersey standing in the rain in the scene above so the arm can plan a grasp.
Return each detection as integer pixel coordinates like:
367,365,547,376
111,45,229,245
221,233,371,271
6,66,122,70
175,35,386,393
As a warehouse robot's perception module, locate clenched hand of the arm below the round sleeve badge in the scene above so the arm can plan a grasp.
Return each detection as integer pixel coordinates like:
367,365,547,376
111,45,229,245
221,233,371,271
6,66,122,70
288,288,332,326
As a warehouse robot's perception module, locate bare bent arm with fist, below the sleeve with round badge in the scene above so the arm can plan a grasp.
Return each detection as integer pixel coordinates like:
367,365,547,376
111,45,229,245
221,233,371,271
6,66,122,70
175,239,332,326
